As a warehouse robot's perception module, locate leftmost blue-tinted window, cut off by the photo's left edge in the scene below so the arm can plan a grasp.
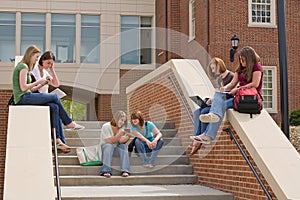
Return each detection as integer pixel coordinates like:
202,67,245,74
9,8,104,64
0,13,16,62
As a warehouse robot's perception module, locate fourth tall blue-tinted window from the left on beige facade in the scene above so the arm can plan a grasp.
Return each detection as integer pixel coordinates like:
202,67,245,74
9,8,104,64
80,15,100,63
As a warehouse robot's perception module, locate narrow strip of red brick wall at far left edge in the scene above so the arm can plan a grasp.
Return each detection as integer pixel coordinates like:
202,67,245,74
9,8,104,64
0,90,12,197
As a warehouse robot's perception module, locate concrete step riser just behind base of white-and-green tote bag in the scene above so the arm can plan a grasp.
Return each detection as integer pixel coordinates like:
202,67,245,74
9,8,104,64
58,154,189,166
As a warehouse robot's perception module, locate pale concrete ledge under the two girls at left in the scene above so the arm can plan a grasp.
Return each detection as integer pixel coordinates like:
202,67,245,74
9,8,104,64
3,106,55,200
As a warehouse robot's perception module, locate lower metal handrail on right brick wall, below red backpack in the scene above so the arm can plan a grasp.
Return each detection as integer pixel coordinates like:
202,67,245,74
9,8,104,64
223,128,272,200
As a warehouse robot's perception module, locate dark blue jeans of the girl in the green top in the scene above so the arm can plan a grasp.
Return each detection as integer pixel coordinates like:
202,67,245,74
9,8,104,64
16,92,72,143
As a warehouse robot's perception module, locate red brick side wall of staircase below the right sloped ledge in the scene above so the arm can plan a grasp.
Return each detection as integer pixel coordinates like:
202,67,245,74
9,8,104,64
128,71,276,200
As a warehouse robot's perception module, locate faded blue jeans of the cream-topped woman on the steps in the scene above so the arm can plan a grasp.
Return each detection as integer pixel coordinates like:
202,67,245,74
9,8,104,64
100,143,130,175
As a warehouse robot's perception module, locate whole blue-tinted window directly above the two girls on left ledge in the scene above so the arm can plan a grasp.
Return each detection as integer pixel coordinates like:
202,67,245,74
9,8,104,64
21,13,46,55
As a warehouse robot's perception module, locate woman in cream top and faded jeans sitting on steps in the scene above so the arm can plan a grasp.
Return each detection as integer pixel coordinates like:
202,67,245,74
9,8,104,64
100,111,130,178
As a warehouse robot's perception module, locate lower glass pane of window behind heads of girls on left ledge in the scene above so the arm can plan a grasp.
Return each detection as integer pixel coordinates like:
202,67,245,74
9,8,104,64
21,26,46,55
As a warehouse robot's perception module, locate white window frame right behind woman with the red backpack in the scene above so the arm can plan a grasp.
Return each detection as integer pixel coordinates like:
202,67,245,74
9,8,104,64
262,66,278,113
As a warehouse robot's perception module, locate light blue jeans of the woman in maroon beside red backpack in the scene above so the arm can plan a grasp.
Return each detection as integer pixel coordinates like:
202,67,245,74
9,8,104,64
203,92,233,140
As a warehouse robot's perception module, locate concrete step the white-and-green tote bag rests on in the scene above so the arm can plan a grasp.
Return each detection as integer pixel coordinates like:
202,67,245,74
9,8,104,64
59,165,193,176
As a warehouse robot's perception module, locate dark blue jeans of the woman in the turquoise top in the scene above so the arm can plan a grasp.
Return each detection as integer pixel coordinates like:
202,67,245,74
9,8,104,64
135,138,164,166
